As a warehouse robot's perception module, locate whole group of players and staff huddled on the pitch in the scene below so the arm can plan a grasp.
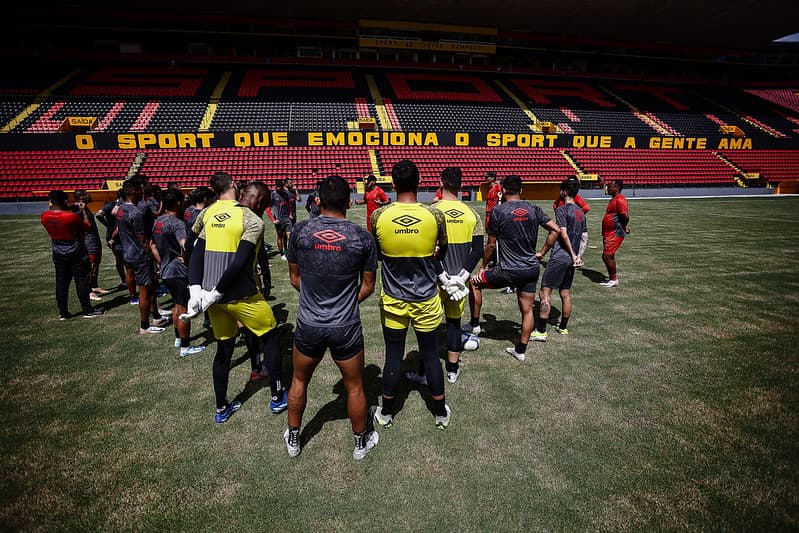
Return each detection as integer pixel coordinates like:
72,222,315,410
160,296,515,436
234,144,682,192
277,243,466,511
42,160,629,459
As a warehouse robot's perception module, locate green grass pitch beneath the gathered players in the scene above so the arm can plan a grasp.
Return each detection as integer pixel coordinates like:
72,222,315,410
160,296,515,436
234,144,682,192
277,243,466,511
0,197,799,532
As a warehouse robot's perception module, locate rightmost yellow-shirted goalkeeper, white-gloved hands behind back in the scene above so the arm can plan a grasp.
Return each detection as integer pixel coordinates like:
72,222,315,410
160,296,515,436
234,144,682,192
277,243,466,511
405,167,483,384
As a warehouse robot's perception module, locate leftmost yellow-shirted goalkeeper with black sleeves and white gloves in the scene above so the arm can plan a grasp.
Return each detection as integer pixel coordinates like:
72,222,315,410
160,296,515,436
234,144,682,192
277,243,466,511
188,172,288,424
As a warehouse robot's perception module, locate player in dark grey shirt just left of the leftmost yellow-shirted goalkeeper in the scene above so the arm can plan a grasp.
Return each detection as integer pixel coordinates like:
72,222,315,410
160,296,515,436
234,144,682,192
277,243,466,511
150,189,205,357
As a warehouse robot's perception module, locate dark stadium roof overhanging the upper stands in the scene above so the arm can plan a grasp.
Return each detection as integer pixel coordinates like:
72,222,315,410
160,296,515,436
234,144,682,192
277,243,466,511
60,0,799,50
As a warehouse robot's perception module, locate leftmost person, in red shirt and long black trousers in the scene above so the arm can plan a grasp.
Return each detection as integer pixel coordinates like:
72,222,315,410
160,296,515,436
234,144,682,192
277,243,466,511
41,190,103,320
